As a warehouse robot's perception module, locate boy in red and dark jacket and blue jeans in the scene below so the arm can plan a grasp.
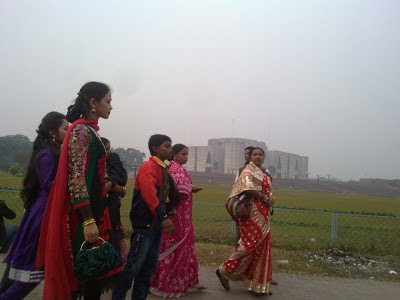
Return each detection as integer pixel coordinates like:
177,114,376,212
112,134,179,300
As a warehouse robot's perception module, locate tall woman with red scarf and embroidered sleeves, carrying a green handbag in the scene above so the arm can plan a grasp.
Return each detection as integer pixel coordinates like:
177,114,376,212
36,82,122,300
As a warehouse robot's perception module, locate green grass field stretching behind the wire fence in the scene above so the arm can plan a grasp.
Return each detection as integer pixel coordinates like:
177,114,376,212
0,173,400,255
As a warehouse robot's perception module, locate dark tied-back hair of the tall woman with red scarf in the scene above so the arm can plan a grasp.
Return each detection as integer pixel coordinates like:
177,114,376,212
67,81,110,123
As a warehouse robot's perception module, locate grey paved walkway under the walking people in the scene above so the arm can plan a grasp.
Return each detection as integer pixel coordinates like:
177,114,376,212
0,256,400,300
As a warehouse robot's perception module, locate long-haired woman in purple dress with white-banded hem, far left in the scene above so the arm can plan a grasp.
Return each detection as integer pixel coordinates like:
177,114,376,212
0,112,69,300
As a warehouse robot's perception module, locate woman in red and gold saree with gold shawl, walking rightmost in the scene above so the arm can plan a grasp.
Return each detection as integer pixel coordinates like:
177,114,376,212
216,147,275,294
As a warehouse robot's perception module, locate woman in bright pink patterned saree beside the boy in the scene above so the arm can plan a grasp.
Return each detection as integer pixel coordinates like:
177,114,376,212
150,144,205,298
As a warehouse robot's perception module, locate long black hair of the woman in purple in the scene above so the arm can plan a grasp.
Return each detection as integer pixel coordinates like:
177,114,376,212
20,111,65,211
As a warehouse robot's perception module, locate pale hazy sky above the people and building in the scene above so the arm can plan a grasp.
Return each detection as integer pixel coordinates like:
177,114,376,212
0,0,400,179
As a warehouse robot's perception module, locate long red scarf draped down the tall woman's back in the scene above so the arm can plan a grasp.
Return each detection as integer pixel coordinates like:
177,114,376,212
36,118,99,300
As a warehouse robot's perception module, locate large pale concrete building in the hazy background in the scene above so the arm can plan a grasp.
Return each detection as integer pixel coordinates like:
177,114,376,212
186,138,308,179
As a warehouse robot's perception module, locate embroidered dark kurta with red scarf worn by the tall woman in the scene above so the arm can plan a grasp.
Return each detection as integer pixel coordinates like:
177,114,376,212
36,119,122,300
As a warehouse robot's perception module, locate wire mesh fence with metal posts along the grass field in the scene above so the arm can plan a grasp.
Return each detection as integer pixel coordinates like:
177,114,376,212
0,189,400,256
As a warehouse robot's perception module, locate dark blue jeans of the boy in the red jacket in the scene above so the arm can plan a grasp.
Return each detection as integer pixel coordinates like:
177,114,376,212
112,220,162,300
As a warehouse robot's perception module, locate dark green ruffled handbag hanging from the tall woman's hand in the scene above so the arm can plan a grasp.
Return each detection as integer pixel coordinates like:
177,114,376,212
74,237,122,280
